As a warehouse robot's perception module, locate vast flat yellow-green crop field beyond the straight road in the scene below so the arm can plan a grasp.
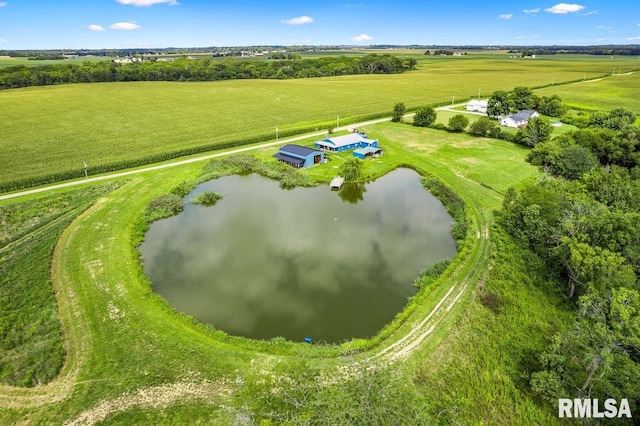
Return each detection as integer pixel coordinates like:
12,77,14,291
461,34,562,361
0,55,629,188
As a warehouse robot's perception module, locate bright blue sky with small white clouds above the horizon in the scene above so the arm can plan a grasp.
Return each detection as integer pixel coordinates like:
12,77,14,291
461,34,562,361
0,0,640,49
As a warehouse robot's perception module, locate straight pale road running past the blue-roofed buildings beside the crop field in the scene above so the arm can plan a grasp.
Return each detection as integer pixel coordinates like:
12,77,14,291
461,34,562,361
0,103,476,201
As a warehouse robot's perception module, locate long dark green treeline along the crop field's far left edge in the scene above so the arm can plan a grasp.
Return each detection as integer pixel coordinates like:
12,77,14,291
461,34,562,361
0,54,417,89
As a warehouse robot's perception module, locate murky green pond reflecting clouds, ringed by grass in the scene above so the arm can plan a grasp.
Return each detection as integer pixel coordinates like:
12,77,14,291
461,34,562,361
140,169,456,343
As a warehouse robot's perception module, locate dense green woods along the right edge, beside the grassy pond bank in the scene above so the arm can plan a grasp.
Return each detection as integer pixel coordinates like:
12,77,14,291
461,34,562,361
499,103,640,411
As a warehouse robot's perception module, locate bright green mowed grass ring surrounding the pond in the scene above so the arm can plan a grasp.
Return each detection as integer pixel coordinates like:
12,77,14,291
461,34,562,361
0,123,563,424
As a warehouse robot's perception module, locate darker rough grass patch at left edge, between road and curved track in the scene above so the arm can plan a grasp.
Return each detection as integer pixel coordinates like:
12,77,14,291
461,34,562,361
0,183,124,386
